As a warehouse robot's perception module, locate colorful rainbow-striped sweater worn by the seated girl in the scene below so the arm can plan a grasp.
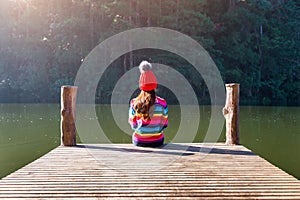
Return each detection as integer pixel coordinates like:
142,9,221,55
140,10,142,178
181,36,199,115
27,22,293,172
128,96,168,144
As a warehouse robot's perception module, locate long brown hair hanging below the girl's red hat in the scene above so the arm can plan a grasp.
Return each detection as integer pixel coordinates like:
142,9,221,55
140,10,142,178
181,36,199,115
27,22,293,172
134,90,156,120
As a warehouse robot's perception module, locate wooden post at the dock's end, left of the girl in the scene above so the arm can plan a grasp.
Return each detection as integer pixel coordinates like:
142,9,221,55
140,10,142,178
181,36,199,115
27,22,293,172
60,86,77,146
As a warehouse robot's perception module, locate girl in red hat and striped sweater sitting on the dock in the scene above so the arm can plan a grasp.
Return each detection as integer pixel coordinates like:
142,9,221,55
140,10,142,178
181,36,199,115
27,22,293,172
128,61,168,147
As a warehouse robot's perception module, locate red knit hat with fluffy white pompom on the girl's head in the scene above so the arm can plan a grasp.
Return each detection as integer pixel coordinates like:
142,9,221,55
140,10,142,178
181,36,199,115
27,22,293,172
139,61,157,91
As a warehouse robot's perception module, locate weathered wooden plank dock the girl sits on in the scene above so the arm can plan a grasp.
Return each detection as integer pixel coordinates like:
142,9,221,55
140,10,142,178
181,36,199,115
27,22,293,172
0,143,300,199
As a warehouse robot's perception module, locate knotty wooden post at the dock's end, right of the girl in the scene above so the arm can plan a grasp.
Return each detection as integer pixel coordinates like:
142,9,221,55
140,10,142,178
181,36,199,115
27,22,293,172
223,83,240,145
